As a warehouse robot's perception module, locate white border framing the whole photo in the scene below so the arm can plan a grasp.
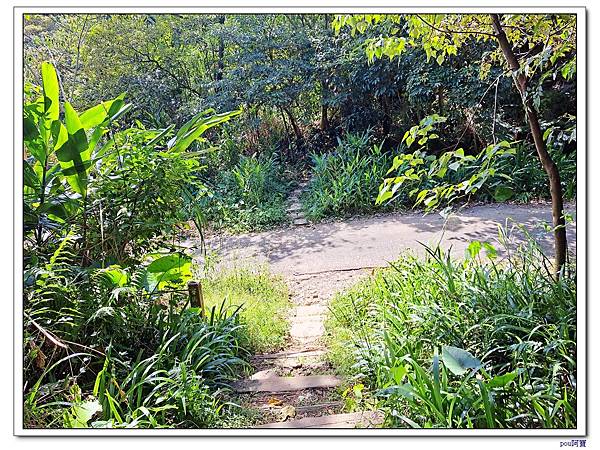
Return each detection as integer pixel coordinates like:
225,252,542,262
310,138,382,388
13,0,589,438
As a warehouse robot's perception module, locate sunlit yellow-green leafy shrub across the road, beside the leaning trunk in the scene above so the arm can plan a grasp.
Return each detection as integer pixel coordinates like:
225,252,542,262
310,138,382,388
377,114,576,209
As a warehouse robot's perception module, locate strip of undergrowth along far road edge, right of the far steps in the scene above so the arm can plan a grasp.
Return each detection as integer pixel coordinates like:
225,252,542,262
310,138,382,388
302,131,577,221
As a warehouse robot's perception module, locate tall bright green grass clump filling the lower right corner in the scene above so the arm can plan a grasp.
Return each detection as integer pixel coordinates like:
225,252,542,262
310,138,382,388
326,237,577,428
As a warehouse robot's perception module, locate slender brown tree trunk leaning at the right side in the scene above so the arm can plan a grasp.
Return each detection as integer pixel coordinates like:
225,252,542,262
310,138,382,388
491,14,567,278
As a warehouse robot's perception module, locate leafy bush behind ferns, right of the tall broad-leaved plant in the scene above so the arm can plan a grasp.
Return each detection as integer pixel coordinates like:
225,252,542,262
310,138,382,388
86,128,203,265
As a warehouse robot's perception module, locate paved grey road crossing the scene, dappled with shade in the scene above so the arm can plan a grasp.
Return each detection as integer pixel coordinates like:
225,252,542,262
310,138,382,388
197,203,576,275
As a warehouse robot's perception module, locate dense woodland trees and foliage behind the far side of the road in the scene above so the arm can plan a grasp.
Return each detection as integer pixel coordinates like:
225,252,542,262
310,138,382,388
25,14,576,231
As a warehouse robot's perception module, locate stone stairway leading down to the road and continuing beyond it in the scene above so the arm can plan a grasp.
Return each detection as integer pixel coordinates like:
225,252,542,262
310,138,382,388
233,201,382,428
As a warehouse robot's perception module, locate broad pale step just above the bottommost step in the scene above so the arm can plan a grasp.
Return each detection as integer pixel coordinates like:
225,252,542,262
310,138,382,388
233,375,342,393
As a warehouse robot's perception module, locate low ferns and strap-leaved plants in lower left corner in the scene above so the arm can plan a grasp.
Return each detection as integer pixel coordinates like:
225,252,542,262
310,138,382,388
23,238,248,427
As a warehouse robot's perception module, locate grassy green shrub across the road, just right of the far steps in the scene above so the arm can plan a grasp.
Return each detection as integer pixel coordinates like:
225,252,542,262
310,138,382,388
302,132,391,220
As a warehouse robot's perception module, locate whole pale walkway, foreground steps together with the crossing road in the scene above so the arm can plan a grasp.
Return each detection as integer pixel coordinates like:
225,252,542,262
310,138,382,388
190,200,576,428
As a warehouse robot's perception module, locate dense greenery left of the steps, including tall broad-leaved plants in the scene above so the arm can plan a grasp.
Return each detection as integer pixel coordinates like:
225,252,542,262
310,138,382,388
23,63,287,428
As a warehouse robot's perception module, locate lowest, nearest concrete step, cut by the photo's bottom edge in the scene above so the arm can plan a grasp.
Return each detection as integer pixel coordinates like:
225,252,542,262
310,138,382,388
257,411,383,428
